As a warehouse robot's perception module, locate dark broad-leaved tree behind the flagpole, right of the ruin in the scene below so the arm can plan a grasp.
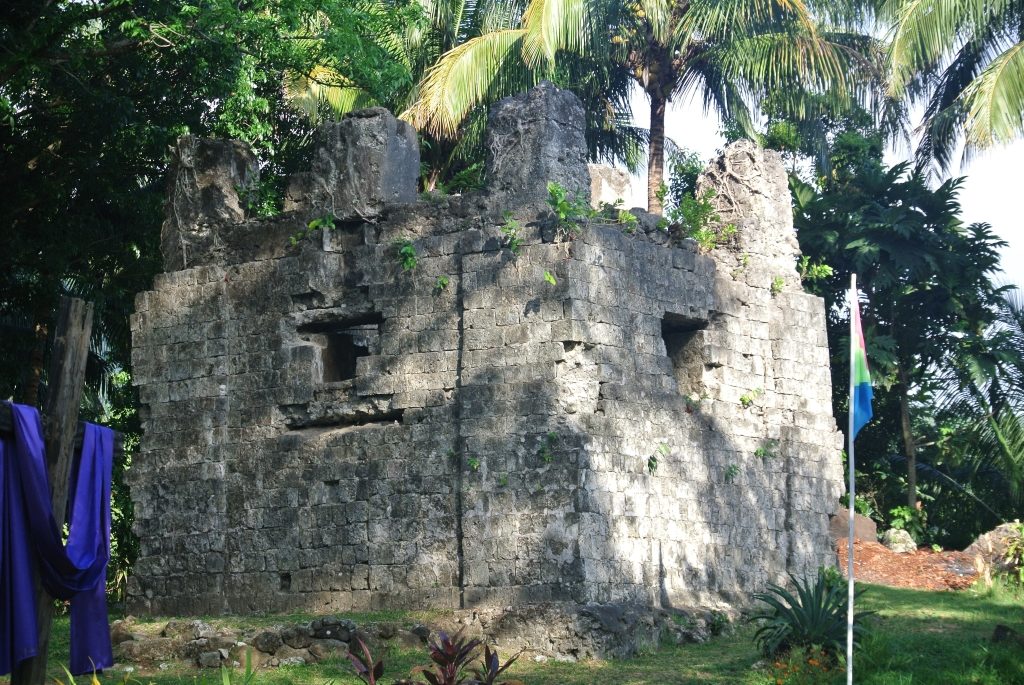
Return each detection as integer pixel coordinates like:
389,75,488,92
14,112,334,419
792,131,1004,507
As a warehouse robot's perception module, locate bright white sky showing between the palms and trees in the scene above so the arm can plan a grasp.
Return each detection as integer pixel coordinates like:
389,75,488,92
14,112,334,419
625,95,1024,286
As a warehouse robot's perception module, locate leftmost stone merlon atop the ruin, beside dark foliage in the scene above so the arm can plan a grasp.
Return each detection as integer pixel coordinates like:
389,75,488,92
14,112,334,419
160,135,259,271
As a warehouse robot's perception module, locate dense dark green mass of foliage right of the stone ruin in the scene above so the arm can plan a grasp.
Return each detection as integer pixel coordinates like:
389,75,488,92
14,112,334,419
762,106,1024,547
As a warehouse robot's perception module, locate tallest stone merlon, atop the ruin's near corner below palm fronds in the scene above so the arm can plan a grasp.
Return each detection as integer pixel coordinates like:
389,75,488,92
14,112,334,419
486,81,590,211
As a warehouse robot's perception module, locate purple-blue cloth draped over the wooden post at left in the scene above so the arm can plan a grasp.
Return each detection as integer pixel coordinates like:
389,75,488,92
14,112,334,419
0,404,114,675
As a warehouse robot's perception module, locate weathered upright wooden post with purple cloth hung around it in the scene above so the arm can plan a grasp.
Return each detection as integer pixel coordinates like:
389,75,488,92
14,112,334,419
10,297,92,685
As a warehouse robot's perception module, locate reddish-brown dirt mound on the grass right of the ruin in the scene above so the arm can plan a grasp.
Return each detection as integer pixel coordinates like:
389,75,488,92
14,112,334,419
838,538,978,590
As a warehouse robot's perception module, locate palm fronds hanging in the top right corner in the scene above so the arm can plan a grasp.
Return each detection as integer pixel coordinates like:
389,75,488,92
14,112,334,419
882,0,1024,170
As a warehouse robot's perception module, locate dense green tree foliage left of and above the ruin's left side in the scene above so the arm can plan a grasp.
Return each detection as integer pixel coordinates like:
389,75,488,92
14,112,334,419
0,0,419,583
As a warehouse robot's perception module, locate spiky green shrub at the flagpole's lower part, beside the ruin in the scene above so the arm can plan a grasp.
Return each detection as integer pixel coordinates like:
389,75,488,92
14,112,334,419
751,572,871,658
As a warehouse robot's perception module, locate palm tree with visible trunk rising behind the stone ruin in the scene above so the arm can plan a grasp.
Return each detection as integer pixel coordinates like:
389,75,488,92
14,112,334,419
410,0,870,213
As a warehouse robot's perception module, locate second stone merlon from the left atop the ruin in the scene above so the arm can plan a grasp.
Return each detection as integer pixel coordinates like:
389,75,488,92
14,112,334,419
285,108,420,219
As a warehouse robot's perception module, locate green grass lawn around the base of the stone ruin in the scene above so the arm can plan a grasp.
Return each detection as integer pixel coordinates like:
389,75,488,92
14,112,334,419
28,586,1024,685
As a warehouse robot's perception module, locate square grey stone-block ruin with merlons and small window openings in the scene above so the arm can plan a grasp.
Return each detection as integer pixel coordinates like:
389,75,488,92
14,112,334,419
129,85,842,634
